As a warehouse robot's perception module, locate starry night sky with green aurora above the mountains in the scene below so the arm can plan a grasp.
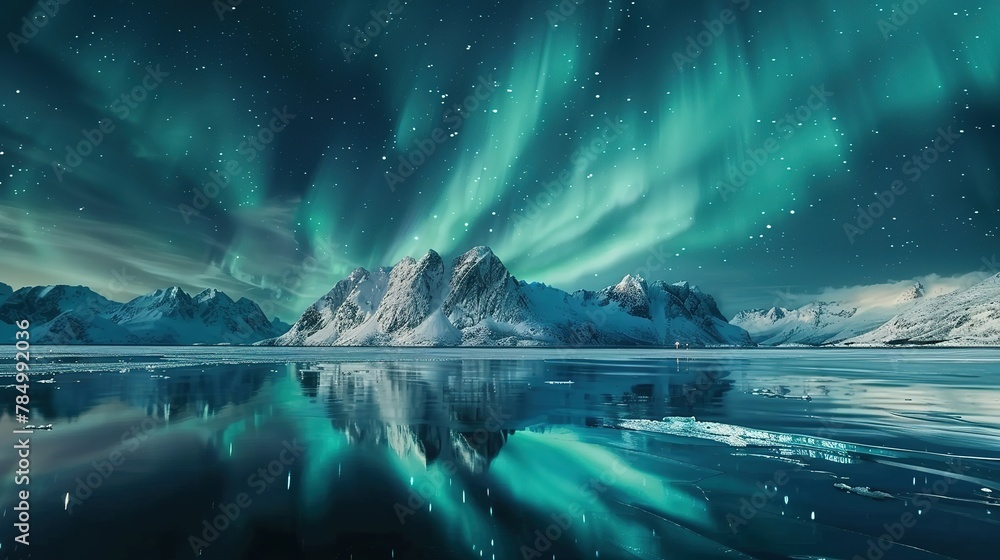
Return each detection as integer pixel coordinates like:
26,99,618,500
0,0,1000,320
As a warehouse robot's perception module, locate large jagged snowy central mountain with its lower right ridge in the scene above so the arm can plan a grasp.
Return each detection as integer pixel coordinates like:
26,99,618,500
261,247,752,346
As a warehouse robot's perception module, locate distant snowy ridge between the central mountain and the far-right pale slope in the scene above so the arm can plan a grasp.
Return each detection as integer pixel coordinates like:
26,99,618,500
730,282,925,346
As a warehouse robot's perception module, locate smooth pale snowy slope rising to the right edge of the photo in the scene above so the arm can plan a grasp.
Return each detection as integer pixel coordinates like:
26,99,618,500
845,274,1000,346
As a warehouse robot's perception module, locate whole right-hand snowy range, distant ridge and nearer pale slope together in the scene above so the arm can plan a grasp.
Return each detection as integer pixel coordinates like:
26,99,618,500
731,275,1000,346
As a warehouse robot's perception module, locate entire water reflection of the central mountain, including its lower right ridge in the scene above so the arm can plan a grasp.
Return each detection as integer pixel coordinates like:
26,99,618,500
297,360,733,472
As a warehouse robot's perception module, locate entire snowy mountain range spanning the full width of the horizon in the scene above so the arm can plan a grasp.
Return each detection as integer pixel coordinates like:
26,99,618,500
0,247,1000,347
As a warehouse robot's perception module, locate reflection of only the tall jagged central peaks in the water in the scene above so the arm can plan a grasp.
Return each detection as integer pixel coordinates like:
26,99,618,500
298,361,541,472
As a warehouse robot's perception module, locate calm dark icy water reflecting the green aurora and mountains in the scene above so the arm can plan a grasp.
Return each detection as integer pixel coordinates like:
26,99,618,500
0,347,1000,560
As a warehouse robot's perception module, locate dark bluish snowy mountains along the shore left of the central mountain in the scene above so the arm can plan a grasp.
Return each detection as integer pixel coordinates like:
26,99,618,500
0,286,284,344
